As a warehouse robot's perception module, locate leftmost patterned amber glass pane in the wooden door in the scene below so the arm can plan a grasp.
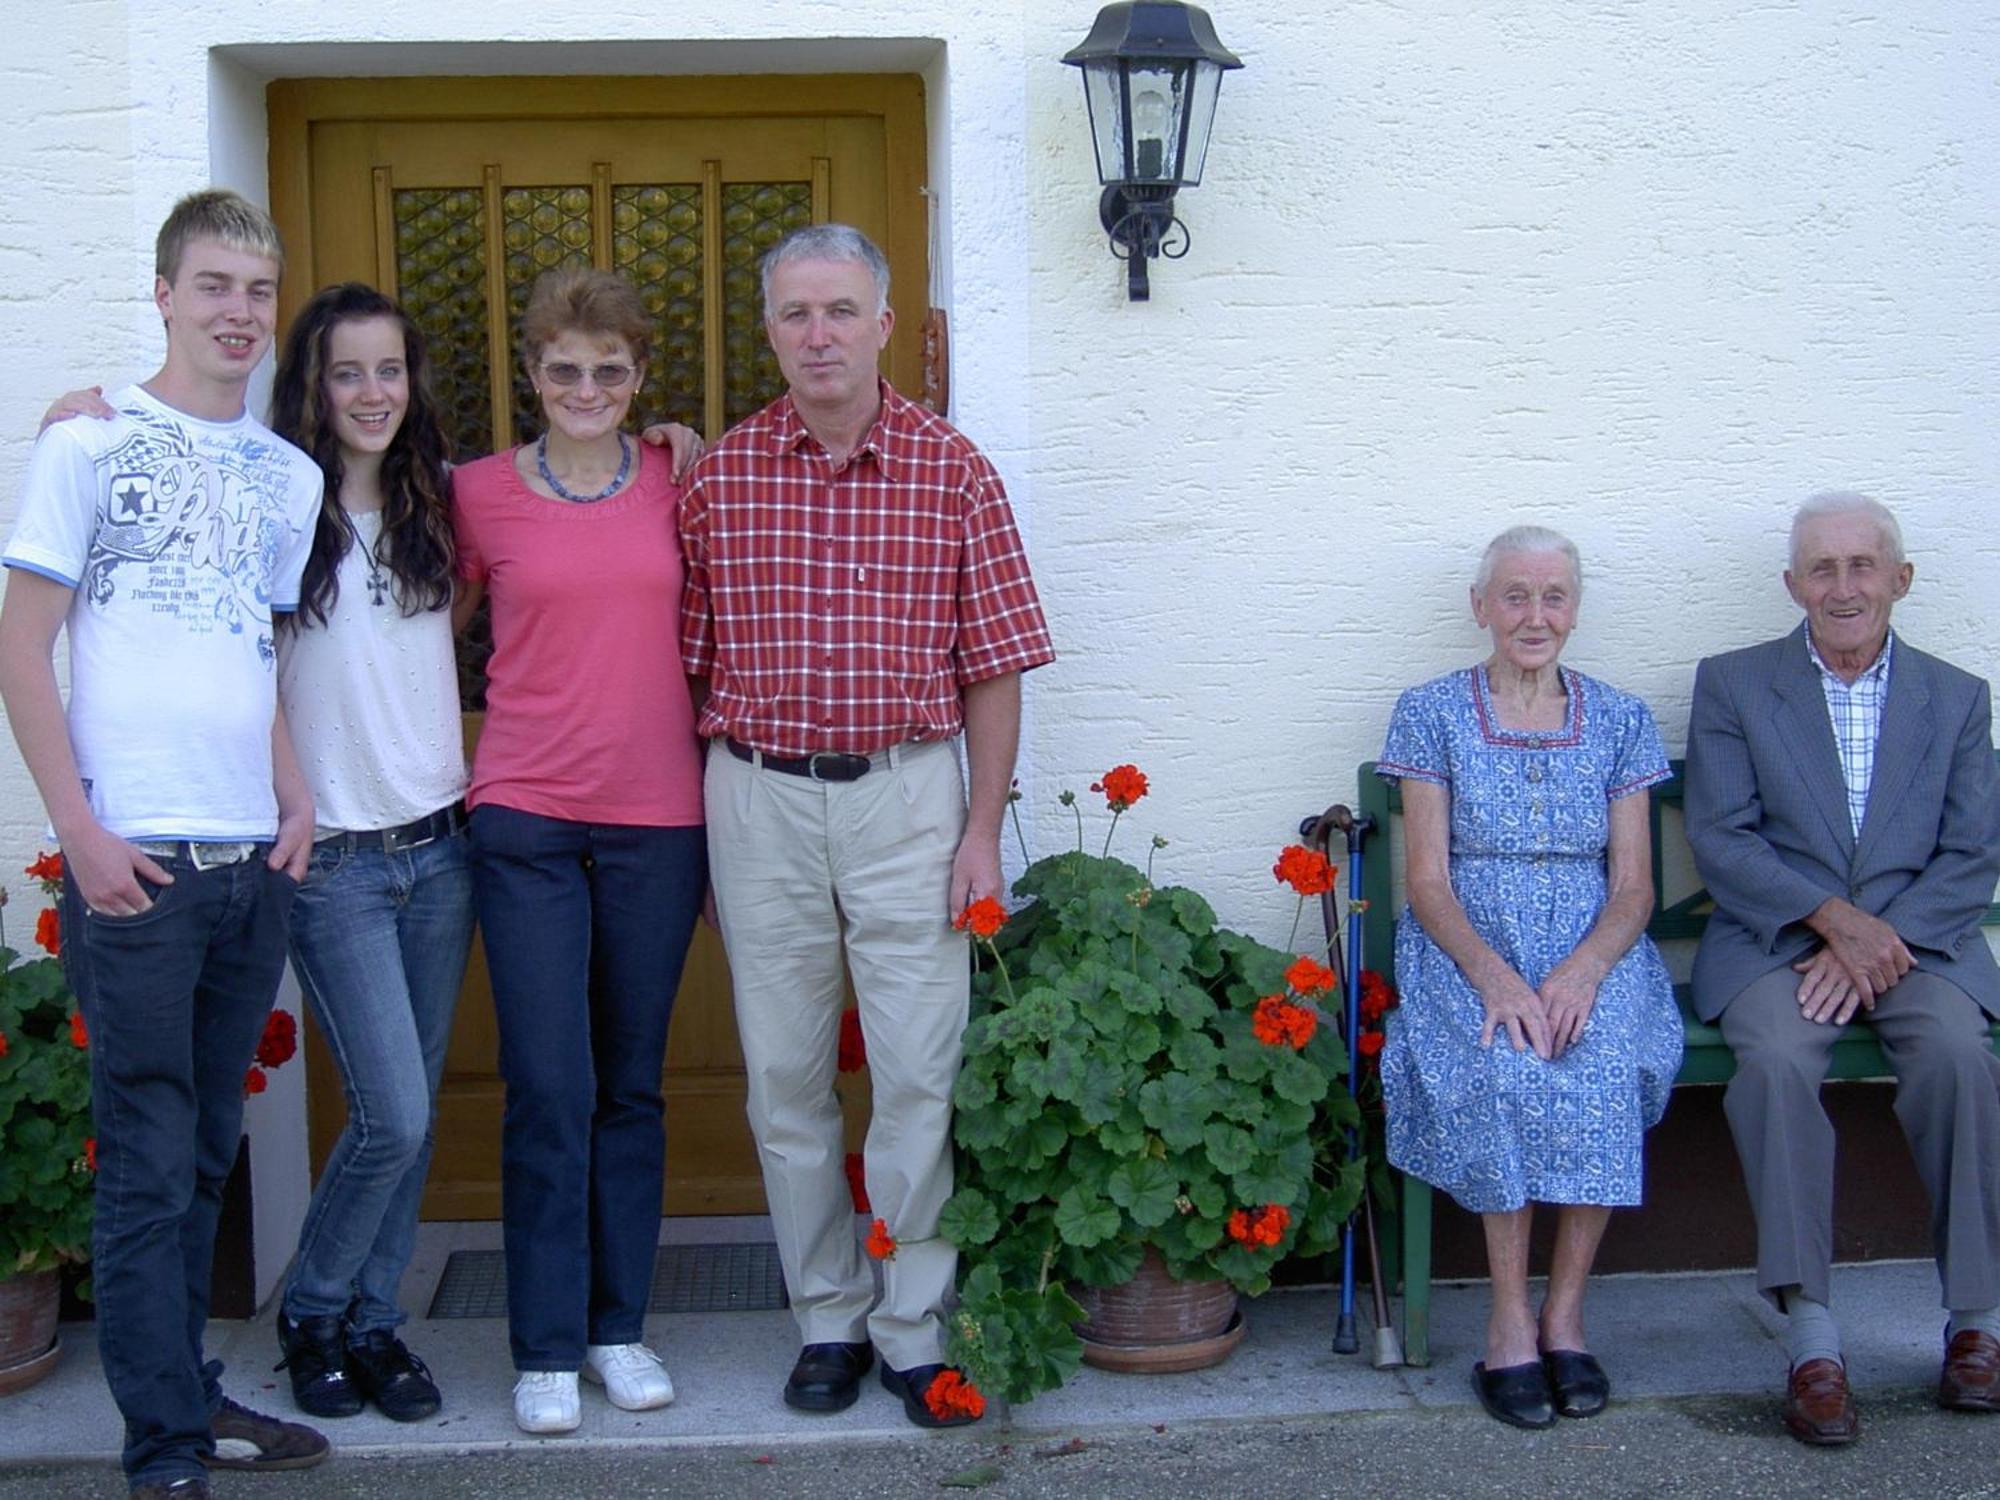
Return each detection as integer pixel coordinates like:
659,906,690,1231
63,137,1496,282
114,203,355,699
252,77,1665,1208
394,188,494,458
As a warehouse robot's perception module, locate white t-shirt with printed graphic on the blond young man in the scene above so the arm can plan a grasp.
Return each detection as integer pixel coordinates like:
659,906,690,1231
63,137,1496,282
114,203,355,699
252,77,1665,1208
0,386,324,840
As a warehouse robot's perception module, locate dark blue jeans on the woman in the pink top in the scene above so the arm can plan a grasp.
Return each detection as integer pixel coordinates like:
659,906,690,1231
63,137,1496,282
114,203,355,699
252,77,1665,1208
472,804,708,1370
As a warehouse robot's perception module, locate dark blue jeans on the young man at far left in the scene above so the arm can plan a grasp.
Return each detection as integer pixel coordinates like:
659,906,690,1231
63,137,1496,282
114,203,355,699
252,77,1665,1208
62,846,296,1484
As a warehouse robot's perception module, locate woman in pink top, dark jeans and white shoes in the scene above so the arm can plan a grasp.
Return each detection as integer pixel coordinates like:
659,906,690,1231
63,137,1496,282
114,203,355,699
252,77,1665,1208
452,270,706,1432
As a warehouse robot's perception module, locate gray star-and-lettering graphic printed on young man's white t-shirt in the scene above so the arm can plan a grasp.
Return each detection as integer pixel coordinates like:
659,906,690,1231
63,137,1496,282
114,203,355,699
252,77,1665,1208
82,406,292,664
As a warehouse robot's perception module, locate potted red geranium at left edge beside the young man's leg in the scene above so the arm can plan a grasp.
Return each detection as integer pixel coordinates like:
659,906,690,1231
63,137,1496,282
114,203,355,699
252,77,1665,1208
0,854,98,1392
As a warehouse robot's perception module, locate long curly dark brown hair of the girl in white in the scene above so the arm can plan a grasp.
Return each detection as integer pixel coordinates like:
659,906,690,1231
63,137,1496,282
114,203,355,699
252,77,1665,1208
270,282,454,628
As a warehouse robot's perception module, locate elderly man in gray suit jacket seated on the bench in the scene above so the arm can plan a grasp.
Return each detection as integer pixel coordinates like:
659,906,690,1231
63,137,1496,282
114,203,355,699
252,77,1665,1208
1686,494,2000,1444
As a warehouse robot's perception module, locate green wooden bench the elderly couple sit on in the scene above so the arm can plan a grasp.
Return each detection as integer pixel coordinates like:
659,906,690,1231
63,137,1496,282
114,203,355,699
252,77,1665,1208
1336,756,2000,1364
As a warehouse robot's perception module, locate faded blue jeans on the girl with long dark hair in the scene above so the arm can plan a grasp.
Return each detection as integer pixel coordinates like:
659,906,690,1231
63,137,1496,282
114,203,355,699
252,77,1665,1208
284,834,472,1334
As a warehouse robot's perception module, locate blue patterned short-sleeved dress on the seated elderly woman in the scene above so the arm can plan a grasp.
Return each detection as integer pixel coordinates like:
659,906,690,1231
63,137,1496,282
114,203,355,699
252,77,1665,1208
1378,666,1680,1214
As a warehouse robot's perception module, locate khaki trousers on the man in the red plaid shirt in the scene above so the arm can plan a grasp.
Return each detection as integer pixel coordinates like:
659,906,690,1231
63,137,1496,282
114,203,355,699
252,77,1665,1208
704,740,972,1370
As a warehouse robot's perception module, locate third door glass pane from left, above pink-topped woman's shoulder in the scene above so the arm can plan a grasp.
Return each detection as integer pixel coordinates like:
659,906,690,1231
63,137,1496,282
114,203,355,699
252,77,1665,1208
612,182,704,432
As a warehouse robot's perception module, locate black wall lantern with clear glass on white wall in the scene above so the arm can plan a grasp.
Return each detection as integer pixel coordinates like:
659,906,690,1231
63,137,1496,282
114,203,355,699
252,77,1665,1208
1062,0,1244,302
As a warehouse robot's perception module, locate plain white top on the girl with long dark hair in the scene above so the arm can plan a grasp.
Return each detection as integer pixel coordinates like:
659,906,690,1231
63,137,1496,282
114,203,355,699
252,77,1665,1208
278,510,466,834
